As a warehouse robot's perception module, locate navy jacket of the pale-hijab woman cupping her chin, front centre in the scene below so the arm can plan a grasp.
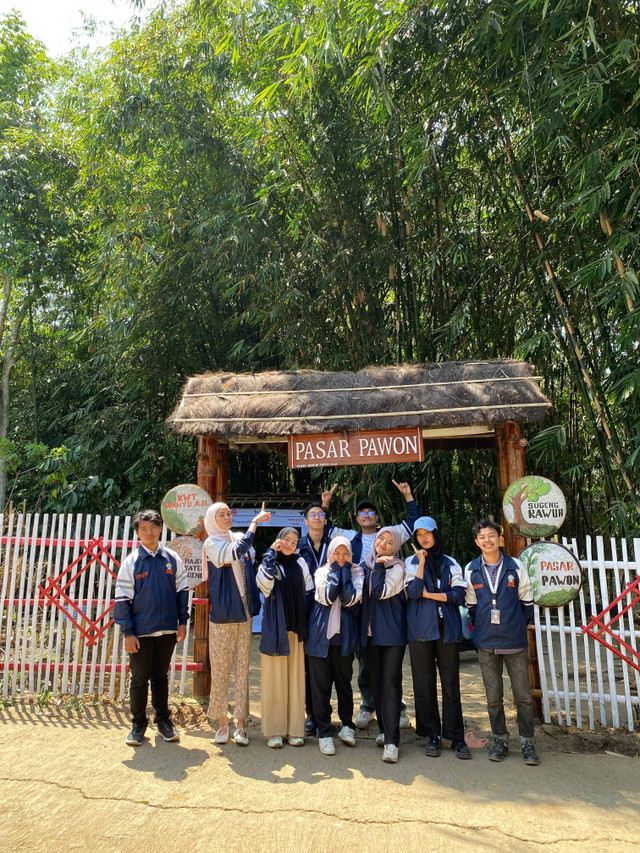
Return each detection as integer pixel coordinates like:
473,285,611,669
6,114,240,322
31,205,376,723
304,563,362,658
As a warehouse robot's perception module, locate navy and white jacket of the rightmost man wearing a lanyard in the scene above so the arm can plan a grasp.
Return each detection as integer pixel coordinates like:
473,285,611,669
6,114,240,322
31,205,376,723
466,554,533,649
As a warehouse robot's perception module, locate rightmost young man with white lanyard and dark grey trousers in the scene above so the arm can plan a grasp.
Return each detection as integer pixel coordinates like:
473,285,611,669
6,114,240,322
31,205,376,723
465,518,540,765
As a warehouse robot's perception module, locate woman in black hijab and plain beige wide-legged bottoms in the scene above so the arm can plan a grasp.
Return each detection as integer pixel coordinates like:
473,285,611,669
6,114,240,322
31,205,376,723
256,527,313,749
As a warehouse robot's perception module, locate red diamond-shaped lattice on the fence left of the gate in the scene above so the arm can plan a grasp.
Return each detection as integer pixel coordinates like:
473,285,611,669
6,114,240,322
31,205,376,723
38,537,120,646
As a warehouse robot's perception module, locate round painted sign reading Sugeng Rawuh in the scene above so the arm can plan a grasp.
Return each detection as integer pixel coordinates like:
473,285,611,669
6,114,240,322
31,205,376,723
502,476,567,537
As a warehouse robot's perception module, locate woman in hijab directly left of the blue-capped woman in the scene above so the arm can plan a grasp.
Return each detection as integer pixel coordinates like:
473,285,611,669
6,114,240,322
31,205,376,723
360,527,407,764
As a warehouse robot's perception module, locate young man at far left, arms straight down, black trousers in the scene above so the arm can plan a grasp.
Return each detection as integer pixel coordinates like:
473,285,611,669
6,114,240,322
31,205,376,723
113,509,189,746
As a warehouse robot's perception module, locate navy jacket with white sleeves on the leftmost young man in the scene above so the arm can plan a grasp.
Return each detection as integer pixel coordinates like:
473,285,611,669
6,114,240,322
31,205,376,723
113,546,189,637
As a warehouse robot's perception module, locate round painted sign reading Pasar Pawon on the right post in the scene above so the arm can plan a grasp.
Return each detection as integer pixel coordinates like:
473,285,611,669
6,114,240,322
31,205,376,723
518,542,582,607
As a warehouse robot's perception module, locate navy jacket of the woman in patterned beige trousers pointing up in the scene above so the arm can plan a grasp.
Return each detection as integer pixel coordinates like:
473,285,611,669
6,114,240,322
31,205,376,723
207,530,260,624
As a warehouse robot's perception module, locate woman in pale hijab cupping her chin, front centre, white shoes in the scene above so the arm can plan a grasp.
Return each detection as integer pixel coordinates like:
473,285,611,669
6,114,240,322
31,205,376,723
305,536,363,755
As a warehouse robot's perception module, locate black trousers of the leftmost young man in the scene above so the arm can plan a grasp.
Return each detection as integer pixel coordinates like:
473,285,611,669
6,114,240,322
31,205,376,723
129,633,176,726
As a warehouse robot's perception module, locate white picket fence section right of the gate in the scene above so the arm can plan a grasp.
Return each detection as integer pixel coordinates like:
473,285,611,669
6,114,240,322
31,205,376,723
535,536,640,731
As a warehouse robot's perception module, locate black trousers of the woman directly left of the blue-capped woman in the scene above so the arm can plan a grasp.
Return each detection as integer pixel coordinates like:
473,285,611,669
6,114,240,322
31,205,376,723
366,644,406,746
